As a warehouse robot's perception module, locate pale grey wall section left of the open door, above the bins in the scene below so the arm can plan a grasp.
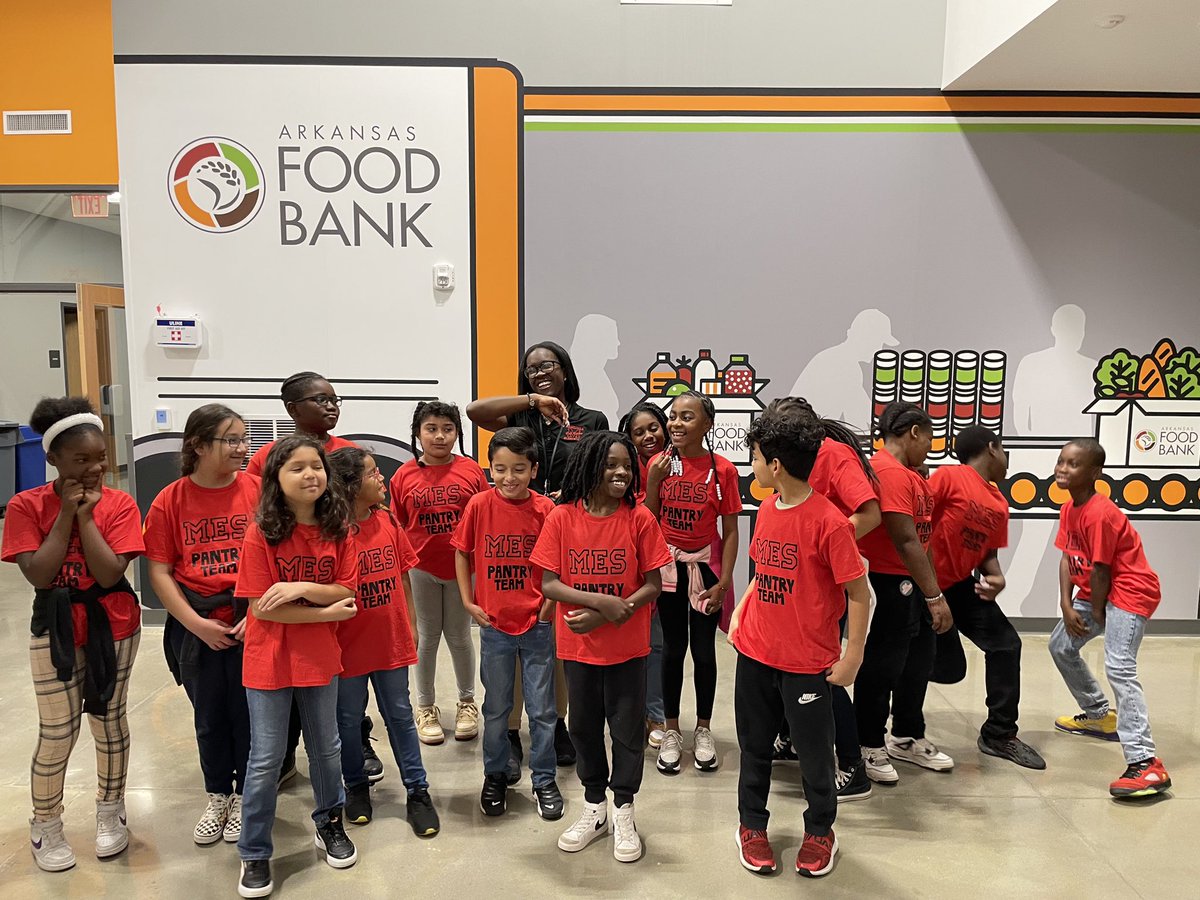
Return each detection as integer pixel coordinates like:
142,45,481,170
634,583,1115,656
0,292,74,422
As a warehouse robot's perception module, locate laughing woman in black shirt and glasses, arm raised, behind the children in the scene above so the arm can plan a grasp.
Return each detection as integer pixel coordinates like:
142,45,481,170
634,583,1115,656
467,341,608,772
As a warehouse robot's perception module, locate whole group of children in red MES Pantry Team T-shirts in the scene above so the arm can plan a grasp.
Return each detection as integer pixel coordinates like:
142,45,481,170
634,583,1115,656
0,360,1170,896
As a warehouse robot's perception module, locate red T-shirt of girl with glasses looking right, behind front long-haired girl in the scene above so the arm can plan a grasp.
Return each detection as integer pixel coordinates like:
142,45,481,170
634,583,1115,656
337,510,416,678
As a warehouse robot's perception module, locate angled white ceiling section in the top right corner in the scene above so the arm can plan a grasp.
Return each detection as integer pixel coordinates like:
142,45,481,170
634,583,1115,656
942,0,1200,92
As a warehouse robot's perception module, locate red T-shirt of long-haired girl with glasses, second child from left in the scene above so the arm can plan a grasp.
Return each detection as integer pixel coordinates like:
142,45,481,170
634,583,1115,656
142,472,260,624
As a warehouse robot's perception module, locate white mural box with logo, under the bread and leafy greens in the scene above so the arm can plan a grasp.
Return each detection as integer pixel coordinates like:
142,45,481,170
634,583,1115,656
1084,397,1200,469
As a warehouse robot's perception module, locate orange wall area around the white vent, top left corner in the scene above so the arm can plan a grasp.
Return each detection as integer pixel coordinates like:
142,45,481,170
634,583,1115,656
0,0,116,186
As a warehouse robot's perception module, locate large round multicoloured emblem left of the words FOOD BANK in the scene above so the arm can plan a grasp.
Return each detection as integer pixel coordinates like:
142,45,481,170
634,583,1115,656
167,137,264,234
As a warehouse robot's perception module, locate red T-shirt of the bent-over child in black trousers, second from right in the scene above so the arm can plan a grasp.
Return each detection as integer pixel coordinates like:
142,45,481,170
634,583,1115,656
929,466,1008,590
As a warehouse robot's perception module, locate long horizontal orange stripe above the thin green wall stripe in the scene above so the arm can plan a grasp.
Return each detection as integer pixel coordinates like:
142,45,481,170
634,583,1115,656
524,91,1200,115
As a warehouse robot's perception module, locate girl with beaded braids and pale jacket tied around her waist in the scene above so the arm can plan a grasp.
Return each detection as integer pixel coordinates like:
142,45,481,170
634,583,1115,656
646,391,742,775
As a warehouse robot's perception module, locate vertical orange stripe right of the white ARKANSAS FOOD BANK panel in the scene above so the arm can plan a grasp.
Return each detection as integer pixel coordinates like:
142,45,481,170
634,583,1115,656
473,67,523,468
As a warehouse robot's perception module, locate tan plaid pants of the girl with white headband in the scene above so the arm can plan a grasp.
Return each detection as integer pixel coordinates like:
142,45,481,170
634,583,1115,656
29,631,142,820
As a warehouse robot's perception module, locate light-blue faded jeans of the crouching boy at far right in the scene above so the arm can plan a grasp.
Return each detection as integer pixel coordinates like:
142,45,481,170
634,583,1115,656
1050,600,1154,763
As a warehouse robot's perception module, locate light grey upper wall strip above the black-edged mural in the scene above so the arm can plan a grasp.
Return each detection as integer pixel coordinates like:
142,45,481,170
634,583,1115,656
113,0,946,88
